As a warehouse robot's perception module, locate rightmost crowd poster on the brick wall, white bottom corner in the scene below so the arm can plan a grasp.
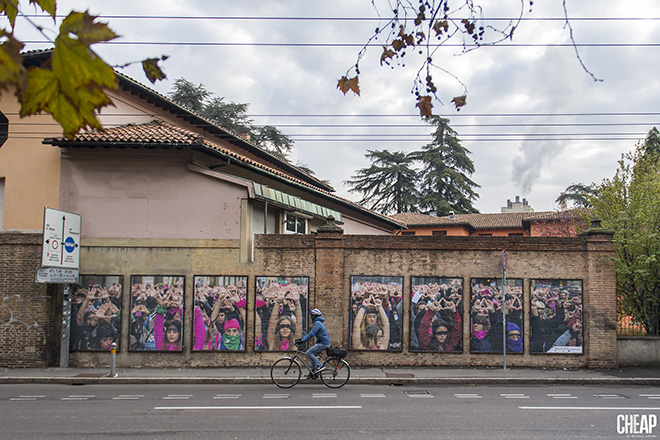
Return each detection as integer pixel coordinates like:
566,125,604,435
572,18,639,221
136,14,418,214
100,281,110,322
530,280,583,354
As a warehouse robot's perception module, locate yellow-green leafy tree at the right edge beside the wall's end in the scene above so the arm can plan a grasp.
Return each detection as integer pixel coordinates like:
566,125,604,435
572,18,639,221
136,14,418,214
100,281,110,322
589,138,660,335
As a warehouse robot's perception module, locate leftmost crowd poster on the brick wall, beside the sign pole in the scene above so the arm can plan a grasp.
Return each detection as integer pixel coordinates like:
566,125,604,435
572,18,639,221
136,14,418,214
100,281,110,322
69,275,123,351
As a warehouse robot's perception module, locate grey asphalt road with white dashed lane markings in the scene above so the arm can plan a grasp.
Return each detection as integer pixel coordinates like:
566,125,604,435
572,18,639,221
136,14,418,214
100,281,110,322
0,384,660,440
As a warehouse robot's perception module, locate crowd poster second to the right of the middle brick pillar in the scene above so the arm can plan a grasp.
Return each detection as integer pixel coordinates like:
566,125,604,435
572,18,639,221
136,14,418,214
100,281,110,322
410,277,463,353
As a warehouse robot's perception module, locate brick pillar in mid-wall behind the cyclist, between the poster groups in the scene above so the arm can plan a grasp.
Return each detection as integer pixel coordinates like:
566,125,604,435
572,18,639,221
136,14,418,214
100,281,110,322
314,217,349,348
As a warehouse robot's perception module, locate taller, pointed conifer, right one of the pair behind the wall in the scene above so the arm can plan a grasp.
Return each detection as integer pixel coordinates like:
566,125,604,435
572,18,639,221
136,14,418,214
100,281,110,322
419,116,479,215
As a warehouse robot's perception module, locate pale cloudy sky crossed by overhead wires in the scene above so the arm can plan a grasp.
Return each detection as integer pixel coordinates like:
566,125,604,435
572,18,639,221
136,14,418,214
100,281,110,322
16,0,660,213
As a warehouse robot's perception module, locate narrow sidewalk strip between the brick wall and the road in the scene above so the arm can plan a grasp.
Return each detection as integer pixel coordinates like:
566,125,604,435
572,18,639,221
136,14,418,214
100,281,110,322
0,367,660,386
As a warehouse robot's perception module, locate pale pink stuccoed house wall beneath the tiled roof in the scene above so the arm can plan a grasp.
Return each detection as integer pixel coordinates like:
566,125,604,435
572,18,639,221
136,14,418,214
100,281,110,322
60,149,247,239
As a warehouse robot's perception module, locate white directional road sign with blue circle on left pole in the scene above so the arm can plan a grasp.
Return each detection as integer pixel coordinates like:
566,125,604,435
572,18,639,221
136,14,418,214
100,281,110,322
41,208,80,269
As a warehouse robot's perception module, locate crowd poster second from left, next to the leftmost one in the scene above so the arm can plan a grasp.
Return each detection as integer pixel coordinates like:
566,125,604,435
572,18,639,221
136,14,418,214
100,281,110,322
129,275,185,352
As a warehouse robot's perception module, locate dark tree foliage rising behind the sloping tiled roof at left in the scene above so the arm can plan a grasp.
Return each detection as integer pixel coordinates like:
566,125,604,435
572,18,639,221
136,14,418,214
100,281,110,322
168,78,294,160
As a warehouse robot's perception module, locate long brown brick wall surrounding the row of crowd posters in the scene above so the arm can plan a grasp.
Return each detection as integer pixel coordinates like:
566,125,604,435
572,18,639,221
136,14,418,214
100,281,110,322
0,225,617,368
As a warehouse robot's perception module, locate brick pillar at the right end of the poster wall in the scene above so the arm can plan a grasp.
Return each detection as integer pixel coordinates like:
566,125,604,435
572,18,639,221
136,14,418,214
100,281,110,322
580,220,618,368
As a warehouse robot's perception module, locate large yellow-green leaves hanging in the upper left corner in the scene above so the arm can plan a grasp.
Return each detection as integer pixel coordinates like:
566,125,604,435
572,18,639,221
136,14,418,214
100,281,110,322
0,0,167,138
